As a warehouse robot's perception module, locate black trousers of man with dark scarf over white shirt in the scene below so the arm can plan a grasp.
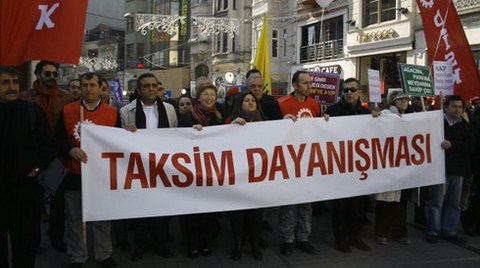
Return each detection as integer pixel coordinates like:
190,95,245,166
130,217,170,250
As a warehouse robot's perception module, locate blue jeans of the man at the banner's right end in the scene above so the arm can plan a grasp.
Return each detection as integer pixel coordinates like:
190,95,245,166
427,175,463,237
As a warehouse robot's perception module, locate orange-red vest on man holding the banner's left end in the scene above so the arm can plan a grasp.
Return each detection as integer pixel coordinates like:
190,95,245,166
63,101,118,174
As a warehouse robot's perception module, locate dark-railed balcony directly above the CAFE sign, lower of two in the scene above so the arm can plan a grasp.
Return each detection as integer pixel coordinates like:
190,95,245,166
300,39,343,63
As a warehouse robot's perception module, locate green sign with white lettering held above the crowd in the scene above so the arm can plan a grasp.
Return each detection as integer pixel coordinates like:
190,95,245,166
400,64,435,97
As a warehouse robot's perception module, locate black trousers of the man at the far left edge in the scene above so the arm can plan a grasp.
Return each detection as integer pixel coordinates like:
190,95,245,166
0,177,43,268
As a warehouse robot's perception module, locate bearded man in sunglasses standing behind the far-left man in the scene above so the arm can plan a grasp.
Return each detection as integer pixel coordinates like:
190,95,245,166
19,61,73,252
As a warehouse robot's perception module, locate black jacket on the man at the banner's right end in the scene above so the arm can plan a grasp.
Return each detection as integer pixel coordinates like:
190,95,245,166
444,119,475,176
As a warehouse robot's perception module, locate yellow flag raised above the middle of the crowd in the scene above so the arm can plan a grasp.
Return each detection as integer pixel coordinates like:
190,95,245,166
253,14,272,94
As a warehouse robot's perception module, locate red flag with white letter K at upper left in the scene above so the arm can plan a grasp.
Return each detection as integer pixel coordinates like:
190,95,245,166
0,0,88,65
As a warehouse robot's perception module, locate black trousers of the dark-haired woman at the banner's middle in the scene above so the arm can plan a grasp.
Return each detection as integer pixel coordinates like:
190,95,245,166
229,209,263,248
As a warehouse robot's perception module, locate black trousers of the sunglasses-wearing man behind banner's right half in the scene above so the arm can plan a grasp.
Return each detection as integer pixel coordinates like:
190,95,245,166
332,196,366,245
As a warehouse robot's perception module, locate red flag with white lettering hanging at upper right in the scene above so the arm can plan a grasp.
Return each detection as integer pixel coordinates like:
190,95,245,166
416,0,480,99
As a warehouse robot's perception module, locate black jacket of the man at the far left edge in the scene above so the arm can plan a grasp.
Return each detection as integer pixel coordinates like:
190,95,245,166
0,100,55,182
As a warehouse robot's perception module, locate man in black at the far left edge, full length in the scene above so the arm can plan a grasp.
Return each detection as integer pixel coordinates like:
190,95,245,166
0,66,55,267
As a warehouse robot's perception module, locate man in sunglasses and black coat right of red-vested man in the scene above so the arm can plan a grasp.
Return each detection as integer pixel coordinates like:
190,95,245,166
326,78,380,253
